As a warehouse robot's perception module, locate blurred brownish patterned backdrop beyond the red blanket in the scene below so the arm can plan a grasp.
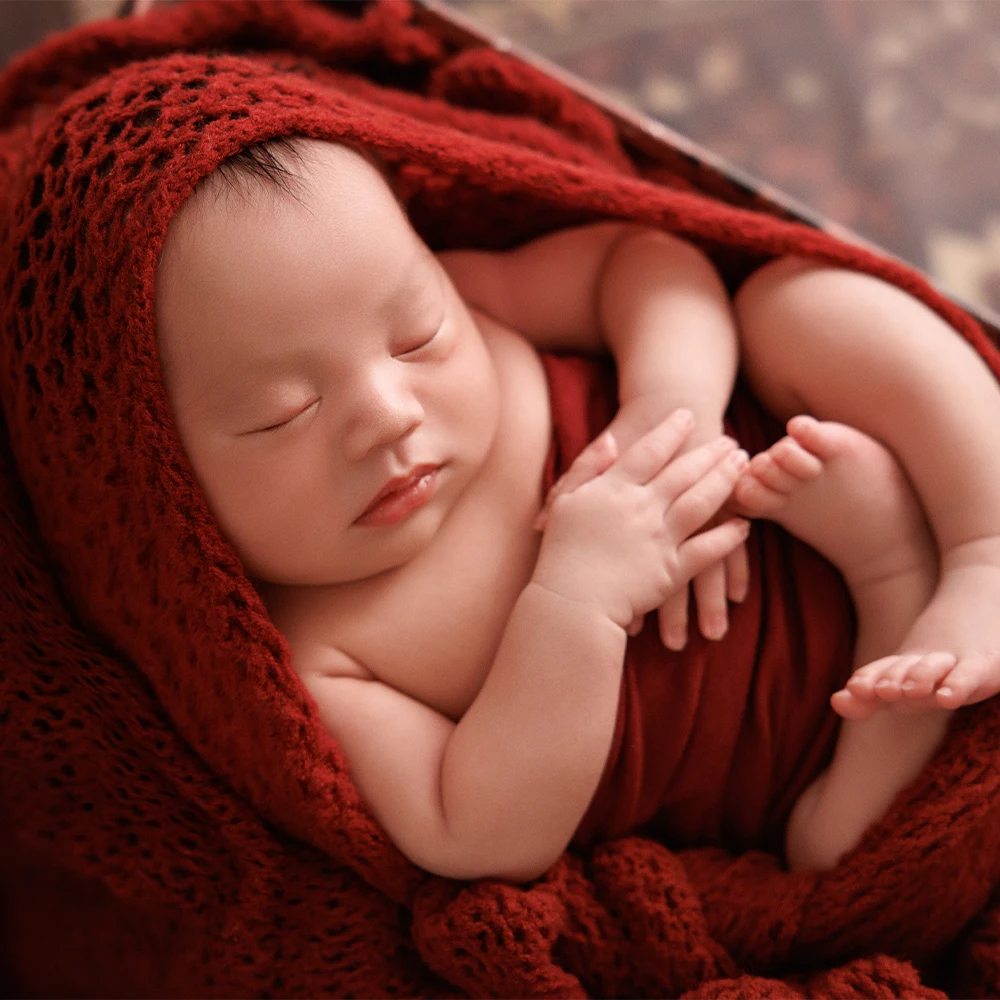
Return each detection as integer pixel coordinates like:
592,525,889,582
0,0,1000,312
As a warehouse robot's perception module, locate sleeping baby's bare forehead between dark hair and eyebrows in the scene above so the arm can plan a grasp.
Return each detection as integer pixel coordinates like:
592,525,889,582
157,142,435,384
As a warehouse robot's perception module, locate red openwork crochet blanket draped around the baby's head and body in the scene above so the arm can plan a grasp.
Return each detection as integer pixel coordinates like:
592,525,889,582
0,0,1000,997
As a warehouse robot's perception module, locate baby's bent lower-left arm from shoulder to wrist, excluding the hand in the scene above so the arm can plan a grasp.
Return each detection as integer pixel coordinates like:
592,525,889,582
304,583,626,881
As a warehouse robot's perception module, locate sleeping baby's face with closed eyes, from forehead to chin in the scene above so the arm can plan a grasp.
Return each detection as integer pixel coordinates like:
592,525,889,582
157,141,499,585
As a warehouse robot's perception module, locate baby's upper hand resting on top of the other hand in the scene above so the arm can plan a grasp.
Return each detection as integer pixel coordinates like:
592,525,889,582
532,410,749,629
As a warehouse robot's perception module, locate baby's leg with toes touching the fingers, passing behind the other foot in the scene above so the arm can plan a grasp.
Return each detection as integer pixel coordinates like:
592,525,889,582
734,416,954,870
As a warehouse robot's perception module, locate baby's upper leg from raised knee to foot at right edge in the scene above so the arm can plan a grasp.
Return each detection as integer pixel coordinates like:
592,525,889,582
735,259,1000,708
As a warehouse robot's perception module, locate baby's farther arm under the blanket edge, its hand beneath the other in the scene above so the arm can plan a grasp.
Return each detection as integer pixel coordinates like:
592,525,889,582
440,222,747,649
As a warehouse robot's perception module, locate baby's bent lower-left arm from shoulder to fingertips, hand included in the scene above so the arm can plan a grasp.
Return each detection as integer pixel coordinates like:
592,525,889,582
302,418,745,880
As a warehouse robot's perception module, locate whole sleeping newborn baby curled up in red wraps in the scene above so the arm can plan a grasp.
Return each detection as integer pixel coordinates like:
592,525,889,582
157,140,1000,880
